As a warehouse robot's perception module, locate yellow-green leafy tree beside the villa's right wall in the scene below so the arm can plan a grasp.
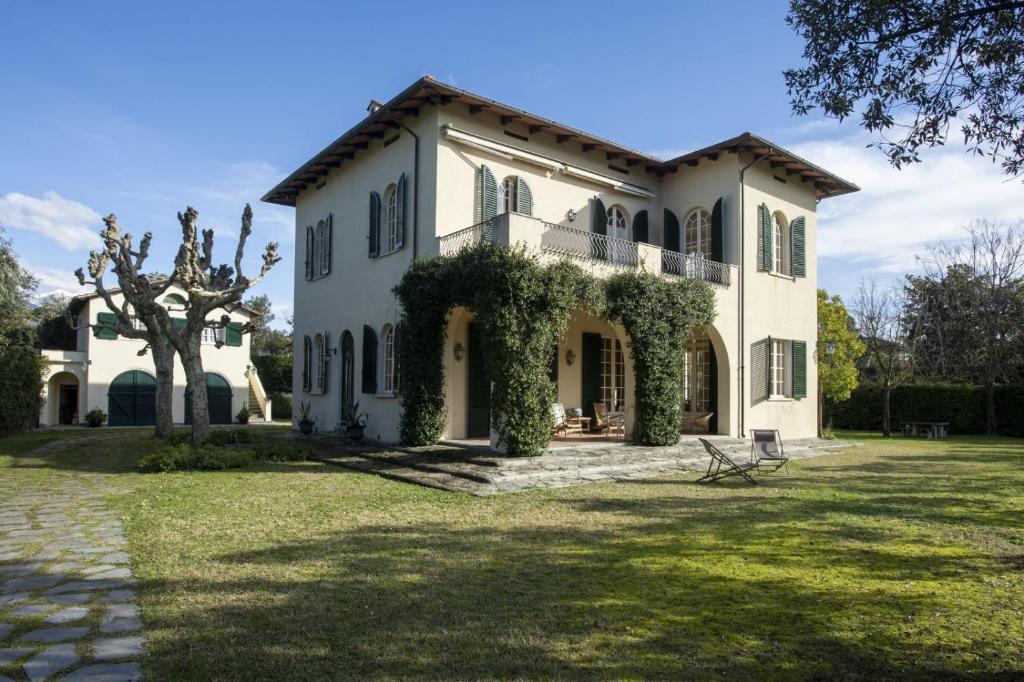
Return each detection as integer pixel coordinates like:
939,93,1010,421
818,289,866,434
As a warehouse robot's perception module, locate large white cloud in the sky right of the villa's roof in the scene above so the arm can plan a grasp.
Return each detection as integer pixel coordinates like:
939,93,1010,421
793,135,1024,273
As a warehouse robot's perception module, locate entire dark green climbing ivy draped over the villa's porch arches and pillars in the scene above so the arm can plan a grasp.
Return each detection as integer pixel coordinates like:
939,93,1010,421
394,245,714,455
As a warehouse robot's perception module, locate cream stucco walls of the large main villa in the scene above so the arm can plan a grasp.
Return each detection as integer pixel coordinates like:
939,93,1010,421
294,98,831,441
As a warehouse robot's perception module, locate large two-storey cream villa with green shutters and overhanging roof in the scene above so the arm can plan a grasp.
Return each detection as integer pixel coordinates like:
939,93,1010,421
263,77,858,441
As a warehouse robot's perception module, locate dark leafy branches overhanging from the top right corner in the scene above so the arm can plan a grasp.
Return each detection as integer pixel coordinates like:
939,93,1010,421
785,0,1024,175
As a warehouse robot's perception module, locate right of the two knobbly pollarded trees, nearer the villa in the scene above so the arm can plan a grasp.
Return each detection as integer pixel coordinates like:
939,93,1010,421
161,204,281,444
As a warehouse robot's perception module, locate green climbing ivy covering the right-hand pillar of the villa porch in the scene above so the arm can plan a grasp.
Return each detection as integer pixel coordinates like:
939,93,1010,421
607,272,715,445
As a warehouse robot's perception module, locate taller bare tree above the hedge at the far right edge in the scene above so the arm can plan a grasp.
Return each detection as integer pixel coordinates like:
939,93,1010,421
923,220,1024,434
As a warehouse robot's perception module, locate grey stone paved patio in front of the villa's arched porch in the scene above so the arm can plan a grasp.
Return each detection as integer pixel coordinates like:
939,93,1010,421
322,436,848,496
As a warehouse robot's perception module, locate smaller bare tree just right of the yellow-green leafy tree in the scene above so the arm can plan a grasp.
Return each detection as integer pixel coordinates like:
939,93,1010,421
852,280,918,437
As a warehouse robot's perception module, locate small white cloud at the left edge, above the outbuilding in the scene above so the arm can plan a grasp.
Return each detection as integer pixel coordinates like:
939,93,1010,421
0,191,101,251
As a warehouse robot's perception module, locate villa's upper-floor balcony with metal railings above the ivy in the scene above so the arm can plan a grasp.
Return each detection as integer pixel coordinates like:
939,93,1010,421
437,213,735,287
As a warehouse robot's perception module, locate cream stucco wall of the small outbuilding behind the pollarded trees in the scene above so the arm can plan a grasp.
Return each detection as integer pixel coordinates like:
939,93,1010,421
40,288,250,425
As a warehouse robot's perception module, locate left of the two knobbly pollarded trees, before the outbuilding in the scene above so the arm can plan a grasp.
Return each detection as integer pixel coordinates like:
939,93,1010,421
75,213,174,438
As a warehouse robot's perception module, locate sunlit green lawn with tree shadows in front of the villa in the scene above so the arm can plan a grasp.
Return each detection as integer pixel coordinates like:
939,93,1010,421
0,431,1024,680
